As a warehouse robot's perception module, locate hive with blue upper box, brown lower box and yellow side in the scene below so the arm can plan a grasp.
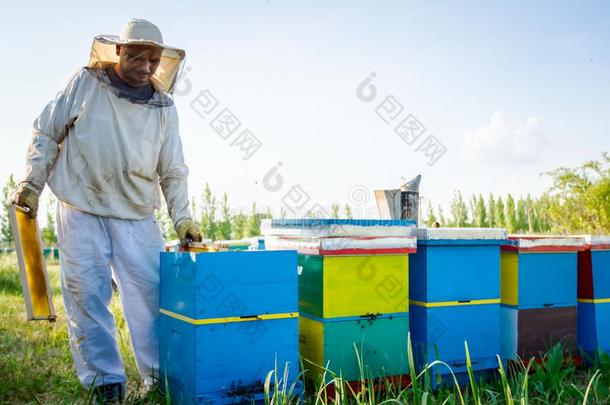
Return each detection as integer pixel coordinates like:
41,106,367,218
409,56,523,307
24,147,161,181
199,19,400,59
501,236,584,359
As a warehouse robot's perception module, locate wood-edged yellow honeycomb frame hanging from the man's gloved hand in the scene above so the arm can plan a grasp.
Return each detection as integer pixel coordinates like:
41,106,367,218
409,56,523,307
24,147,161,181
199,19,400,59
9,205,55,322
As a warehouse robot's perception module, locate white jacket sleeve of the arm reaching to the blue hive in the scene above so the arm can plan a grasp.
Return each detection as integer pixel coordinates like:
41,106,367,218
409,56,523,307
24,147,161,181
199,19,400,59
157,105,191,227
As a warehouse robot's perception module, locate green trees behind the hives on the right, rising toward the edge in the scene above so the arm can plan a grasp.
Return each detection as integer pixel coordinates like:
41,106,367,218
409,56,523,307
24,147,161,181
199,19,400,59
424,152,610,234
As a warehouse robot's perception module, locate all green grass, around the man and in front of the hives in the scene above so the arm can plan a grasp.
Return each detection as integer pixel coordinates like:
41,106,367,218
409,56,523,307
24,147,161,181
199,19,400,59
0,256,610,405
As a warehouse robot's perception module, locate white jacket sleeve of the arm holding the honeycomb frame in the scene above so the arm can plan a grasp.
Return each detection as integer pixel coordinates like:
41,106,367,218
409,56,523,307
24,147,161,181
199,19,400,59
21,69,87,194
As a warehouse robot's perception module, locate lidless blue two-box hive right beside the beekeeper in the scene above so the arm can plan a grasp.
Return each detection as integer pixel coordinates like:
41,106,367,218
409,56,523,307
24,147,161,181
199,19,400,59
160,251,299,404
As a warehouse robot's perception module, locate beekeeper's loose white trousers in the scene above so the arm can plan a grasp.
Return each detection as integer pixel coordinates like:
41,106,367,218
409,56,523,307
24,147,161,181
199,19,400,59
57,202,164,388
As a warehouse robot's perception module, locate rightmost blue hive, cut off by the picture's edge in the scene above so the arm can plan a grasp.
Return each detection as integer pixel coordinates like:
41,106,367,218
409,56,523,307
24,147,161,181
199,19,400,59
578,236,610,362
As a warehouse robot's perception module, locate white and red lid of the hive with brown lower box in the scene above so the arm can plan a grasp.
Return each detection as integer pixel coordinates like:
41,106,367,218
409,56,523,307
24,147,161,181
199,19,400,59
504,235,585,252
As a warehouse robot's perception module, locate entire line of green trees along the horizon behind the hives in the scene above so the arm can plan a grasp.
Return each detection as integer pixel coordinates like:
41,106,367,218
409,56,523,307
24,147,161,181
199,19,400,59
0,152,610,246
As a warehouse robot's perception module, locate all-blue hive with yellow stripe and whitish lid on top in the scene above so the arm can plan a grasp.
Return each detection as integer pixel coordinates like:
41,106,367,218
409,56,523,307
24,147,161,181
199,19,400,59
409,228,506,386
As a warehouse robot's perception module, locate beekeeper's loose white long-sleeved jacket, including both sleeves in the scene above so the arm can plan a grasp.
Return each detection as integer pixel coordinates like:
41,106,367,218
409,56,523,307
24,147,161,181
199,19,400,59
25,68,190,225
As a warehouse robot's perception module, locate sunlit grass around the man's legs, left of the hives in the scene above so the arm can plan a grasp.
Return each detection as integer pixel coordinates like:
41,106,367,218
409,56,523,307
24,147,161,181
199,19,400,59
0,256,159,404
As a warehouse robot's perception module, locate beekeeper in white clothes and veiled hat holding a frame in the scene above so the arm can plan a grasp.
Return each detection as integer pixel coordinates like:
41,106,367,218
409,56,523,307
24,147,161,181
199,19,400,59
13,19,201,402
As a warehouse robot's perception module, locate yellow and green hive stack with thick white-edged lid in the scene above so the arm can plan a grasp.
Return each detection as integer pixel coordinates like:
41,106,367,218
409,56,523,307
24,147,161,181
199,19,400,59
262,220,416,381
